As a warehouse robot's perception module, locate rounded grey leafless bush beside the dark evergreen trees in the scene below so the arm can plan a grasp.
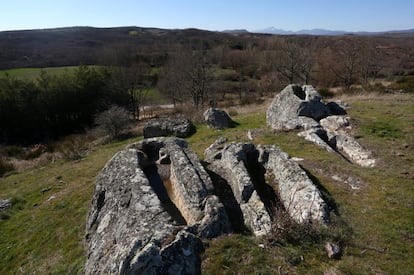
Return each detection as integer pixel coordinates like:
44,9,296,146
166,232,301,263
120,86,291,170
95,106,129,138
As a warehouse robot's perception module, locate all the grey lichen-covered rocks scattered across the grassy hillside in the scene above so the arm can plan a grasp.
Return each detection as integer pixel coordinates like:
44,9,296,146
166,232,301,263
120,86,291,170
84,85,375,274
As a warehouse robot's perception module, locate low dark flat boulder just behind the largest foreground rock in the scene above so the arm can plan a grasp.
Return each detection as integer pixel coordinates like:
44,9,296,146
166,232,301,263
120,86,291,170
144,115,196,138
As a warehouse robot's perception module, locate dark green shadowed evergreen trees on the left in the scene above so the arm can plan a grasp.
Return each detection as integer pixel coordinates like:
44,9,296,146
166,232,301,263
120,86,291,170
0,66,152,143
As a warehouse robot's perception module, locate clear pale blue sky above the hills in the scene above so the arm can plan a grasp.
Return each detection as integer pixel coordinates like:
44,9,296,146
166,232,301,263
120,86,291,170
0,0,414,31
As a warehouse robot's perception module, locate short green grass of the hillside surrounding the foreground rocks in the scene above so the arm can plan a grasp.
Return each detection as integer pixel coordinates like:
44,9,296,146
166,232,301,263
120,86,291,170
0,94,414,274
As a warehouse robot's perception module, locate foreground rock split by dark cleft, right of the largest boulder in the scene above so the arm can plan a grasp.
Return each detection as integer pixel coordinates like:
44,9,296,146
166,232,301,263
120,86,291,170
204,139,329,235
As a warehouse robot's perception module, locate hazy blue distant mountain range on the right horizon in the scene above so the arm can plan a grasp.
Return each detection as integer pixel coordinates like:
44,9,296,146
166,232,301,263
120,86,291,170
252,27,414,35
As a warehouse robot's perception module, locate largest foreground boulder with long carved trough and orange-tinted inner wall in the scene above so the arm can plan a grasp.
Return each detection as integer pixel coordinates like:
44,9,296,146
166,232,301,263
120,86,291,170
85,138,231,274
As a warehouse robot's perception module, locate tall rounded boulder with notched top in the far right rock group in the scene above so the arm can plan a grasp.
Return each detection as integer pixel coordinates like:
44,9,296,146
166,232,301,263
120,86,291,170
266,84,330,130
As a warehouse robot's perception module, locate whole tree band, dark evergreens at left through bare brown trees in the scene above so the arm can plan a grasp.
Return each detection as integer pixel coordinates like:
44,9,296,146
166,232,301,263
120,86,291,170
0,36,414,143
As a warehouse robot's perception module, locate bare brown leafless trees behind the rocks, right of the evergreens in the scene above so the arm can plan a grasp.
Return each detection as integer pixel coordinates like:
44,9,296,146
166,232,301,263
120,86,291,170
158,36,413,107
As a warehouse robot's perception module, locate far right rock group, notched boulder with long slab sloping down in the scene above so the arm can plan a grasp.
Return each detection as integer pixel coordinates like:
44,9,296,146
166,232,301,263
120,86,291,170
266,84,375,167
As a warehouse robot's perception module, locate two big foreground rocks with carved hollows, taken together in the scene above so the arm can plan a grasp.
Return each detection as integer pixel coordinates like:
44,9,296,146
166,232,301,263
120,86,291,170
85,137,328,274
